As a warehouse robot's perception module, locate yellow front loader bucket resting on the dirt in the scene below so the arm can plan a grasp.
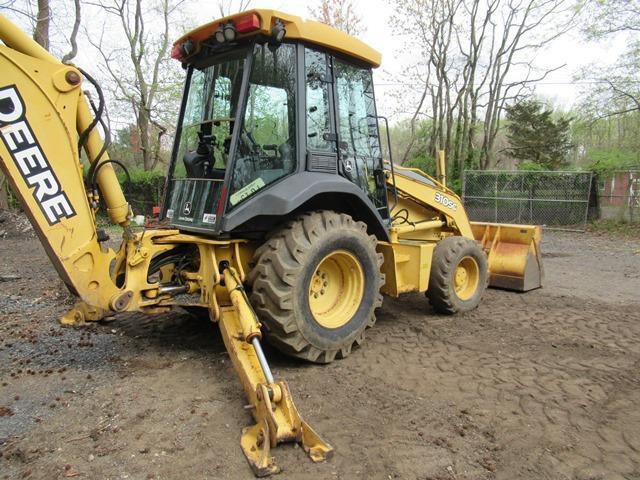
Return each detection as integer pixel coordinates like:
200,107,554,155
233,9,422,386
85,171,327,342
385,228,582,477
471,222,544,292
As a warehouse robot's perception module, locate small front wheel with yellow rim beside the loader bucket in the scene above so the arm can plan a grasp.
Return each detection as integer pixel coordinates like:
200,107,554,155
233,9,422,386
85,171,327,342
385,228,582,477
426,236,488,315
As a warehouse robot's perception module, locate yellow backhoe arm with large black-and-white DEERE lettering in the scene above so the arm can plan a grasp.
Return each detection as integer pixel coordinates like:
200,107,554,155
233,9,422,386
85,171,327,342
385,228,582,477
0,15,130,310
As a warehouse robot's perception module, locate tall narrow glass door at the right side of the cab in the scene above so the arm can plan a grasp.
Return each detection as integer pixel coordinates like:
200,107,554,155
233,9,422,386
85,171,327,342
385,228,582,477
331,57,389,218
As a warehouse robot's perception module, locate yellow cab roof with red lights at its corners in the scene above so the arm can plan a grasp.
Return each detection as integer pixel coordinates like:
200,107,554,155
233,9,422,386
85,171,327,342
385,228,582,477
173,9,382,68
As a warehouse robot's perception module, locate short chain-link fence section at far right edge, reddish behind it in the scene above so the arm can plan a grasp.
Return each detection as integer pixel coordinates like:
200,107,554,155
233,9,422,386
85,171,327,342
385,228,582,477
598,170,640,222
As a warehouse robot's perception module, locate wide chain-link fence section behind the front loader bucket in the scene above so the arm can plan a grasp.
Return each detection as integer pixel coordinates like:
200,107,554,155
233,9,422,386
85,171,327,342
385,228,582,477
462,170,595,230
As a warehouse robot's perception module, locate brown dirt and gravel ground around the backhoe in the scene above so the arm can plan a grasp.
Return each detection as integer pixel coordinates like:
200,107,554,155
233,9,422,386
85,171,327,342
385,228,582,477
0,225,640,480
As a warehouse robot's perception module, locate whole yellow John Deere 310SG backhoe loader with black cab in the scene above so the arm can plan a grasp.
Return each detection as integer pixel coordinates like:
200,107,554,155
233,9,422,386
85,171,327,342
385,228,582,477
0,10,542,476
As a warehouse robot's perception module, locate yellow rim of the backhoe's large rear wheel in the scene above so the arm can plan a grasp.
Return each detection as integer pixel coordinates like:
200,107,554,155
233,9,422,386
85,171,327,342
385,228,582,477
309,250,364,328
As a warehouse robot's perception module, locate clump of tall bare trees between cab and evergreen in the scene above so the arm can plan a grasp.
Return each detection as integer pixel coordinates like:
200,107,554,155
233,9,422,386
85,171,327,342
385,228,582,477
392,0,575,174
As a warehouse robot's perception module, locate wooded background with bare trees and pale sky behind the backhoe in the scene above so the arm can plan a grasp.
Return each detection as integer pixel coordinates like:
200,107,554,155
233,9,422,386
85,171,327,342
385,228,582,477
0,0,640,207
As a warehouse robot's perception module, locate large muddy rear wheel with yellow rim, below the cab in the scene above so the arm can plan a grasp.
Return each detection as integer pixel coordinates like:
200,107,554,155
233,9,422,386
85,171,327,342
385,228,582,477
248,211,384,363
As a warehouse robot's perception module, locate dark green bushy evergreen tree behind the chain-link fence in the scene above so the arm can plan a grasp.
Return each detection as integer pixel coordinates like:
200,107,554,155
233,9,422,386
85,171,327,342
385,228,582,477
506,100,573,170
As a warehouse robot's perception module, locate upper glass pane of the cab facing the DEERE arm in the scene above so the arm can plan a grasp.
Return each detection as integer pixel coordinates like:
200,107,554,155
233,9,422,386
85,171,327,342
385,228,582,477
174,50,246,180
